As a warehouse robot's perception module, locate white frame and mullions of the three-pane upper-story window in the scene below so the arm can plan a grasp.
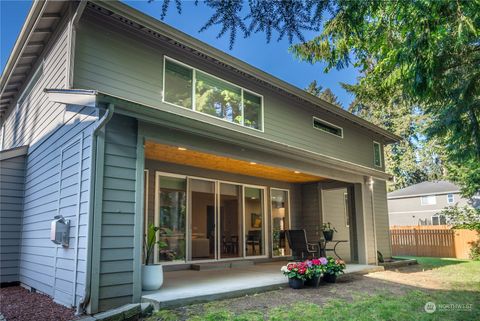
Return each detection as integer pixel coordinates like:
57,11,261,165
162,55,264,135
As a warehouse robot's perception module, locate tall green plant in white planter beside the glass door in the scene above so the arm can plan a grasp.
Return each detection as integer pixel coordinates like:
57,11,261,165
142,224,167,291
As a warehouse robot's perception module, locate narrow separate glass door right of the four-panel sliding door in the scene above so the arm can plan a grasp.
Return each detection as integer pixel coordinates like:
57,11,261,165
270,189,290,256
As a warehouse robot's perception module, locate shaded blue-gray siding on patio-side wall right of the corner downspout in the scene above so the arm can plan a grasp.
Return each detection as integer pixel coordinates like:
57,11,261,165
94,116,137,311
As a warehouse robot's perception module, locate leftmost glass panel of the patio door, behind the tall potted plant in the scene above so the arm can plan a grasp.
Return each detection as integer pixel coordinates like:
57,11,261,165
155,175,187,262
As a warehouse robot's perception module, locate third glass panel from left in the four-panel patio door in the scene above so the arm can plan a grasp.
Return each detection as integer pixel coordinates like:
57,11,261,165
219,183,243,259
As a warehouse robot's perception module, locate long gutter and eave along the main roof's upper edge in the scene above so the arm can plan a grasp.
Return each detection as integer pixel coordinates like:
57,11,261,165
91,0,402,143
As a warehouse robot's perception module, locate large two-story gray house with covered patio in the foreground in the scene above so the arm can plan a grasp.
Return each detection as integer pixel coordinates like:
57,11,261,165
0,1,399,313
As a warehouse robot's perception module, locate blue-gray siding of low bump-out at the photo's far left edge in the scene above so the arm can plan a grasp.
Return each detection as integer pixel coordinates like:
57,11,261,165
0,156,25,283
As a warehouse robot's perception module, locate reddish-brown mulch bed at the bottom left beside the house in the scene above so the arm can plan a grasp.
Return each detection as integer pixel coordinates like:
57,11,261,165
0,286,75,321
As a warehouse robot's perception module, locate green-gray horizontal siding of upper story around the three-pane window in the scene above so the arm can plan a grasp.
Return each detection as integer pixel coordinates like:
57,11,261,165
74,10,386,168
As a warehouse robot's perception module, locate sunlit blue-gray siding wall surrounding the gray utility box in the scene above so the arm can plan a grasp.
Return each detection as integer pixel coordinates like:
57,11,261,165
20,107,96,306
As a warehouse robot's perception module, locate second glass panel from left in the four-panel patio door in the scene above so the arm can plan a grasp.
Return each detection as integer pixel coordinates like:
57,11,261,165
190,179,217,261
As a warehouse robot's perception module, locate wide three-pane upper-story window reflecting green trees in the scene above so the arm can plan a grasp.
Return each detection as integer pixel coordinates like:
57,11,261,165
163,57,263,130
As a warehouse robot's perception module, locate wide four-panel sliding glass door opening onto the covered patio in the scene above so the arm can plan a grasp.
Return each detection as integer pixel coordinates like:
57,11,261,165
154,172,267,263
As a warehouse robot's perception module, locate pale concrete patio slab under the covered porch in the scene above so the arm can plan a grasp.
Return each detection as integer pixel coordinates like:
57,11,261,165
142,262,383,310
